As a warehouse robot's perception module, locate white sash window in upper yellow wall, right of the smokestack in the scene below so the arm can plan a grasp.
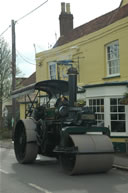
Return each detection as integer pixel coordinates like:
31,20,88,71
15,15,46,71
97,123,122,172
106,41,120,76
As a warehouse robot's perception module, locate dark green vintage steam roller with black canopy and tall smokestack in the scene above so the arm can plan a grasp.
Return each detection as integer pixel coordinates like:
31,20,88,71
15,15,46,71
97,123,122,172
12,67,114,175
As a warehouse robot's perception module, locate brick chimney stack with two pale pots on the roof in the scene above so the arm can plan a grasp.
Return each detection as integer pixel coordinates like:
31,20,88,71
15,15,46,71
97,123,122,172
59,2,73,36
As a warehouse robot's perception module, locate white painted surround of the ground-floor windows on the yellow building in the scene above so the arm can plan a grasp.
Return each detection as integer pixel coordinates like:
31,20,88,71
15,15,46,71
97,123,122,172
85,85,128,137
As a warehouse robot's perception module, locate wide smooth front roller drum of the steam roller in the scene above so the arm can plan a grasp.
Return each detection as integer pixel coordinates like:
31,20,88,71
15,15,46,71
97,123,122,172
60,134,114,175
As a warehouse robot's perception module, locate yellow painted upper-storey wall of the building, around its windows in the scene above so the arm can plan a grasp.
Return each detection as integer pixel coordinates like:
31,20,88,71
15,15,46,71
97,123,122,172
36,18,128,85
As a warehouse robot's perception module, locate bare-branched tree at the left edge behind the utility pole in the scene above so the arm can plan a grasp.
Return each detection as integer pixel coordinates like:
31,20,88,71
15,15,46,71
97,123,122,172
0,38,12,129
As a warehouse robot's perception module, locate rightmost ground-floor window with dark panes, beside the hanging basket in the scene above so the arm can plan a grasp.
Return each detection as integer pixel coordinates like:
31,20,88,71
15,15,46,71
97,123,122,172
110,98,126,132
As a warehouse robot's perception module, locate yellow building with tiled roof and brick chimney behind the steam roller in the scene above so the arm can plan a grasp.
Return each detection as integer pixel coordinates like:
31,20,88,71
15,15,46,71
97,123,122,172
36,0,128,152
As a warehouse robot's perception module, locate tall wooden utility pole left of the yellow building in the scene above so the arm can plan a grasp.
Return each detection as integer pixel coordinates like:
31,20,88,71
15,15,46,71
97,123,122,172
11,20,16,135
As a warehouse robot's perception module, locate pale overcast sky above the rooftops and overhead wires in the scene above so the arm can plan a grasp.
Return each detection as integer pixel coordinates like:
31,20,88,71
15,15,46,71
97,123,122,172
0,0,121,77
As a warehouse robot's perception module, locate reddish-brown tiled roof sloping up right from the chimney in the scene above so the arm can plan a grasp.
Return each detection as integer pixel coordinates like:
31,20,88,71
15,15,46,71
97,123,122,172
54,4,128,48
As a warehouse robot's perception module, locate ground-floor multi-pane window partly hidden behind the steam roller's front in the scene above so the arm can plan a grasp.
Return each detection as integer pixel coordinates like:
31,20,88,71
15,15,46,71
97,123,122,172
89,99,104,126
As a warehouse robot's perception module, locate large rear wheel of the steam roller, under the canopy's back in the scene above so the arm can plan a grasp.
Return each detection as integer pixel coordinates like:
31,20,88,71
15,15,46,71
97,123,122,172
14,119,38,164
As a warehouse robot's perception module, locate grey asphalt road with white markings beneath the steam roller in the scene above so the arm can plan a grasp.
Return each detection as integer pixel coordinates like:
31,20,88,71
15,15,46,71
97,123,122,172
0,148,128,193
